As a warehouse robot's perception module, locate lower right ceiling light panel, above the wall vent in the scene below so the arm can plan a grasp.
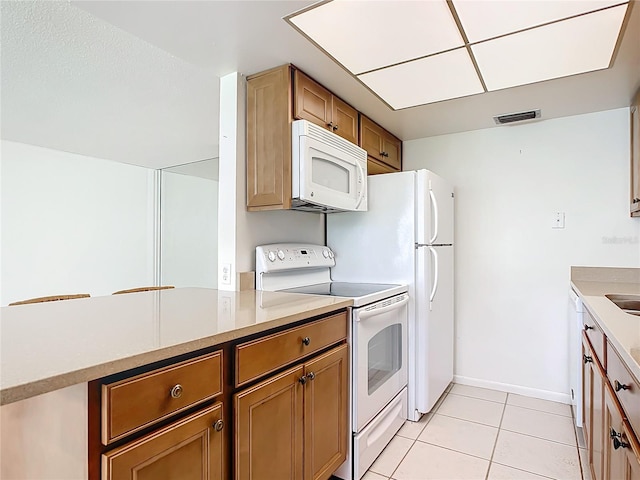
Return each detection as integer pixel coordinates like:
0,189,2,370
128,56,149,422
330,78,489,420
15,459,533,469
471,2,627,91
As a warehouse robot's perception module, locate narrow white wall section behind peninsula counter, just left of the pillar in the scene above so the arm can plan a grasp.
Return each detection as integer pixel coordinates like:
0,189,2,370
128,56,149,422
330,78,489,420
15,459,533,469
160,171,218,288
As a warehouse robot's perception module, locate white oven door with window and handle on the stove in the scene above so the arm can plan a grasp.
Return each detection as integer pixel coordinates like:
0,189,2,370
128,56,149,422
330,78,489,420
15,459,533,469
352,293,409,432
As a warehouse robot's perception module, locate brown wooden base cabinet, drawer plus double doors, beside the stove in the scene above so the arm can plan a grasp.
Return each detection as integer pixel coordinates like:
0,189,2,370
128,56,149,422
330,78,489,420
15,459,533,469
233,314,349,480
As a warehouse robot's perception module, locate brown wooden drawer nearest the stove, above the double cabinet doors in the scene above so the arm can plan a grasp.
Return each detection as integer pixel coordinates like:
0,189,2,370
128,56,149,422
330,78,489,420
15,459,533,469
236,312,347,386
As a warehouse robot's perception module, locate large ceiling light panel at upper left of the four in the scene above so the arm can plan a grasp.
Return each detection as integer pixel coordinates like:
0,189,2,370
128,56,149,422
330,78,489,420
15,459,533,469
288,0,463,74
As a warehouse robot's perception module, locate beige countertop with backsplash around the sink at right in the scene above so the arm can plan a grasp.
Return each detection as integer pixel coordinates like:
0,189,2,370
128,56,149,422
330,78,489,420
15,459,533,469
571,267,640,381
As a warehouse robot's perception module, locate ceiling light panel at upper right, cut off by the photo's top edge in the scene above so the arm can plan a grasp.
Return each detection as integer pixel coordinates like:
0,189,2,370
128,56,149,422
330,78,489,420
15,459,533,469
453,0,625,43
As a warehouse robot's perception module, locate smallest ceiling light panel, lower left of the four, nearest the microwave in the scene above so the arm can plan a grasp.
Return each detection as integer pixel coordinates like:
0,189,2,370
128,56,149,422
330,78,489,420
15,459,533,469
358,48,484,110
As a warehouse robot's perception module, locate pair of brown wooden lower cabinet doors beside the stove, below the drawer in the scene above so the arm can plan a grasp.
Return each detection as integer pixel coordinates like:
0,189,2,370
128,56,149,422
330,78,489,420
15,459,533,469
234,345,349,480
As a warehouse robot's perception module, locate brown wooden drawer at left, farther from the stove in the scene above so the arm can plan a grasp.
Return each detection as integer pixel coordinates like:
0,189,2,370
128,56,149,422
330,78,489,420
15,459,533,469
102,351,222,445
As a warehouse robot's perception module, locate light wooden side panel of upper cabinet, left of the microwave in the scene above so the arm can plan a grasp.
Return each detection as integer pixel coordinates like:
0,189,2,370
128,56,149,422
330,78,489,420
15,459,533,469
247,65,292,210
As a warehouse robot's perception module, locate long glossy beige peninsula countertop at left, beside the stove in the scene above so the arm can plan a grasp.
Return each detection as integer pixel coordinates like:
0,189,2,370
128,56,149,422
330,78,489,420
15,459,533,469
0,288,352,405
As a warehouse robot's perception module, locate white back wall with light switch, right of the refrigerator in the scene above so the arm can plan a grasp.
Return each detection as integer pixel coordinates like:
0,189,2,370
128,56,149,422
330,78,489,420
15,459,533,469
403,108,640,401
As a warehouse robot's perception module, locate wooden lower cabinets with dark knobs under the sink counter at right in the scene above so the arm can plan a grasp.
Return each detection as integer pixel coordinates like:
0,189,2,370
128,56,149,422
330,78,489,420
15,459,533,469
582,311,640,480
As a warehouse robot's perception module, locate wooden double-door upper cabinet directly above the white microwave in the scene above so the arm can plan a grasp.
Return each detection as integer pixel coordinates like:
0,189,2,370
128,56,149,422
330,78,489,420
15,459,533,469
293,70,358,145
